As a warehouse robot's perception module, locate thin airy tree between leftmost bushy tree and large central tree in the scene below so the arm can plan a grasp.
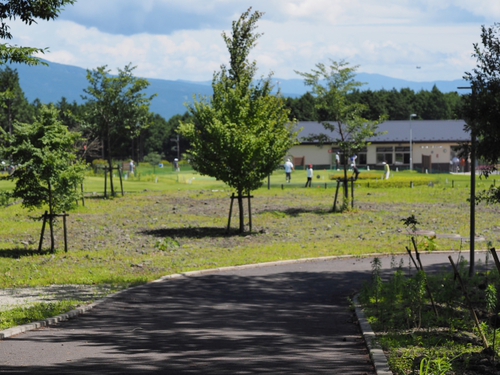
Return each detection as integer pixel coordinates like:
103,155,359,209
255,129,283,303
82,65,154,195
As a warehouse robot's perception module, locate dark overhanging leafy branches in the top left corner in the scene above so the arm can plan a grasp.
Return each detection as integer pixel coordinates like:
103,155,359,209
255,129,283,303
0,0,76,65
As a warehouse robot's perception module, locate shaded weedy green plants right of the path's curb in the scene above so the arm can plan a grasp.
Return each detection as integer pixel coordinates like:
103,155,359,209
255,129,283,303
360,253,500,374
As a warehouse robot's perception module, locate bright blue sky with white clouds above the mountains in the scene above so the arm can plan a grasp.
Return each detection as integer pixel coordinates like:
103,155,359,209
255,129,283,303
9,0,500,82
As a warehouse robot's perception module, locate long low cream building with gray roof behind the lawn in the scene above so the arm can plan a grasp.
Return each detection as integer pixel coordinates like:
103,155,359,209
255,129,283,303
289,120,470,172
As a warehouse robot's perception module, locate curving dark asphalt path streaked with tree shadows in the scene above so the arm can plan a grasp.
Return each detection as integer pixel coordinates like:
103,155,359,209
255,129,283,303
0,253,492,375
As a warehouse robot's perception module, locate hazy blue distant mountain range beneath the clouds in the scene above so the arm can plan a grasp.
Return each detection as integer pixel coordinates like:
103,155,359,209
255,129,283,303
11,62,468,120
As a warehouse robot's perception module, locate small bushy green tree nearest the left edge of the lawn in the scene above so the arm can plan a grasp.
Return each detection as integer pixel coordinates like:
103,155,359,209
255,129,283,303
4,107,85,252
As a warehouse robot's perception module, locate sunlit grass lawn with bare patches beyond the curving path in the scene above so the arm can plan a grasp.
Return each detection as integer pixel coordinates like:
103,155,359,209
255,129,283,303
0,168,500,288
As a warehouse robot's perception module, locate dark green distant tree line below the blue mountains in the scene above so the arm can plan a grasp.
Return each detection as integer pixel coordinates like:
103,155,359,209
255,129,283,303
0,66,463,166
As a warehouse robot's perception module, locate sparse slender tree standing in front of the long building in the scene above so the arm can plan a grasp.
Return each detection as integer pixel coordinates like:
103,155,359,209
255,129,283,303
296,60,385,207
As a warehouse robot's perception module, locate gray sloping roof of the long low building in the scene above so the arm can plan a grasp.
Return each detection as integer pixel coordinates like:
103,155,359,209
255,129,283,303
297,120,470,143
